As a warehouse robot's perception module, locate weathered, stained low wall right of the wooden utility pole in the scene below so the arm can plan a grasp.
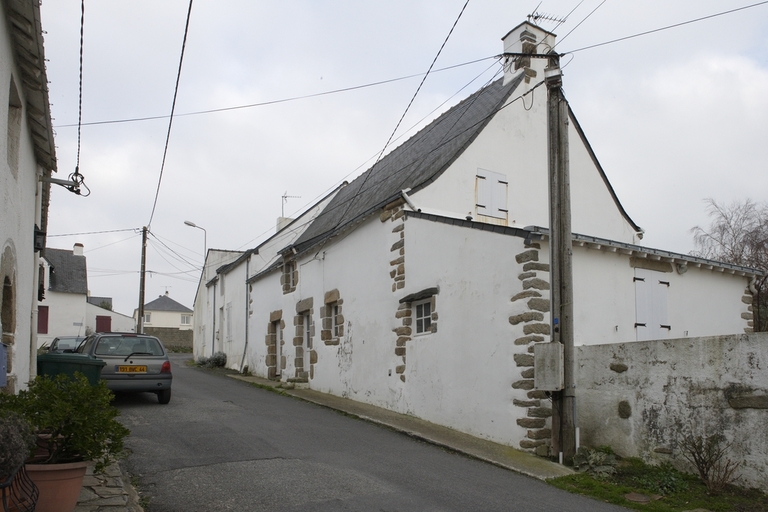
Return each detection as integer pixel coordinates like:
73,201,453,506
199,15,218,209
576,333,768,489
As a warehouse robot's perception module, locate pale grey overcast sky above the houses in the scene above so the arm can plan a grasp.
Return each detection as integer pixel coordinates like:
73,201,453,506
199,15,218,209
42,0,768,315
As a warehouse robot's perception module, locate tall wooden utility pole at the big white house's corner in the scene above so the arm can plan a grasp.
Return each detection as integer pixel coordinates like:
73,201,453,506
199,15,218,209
544,53,576,461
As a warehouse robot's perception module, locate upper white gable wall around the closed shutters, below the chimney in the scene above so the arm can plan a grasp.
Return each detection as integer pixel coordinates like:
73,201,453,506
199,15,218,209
412,23,639,243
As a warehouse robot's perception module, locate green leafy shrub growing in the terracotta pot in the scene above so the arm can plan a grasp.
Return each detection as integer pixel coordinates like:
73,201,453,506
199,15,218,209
0,374,130,471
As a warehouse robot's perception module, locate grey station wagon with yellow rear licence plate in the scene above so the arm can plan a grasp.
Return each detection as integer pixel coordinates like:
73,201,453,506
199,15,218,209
76,332,173,404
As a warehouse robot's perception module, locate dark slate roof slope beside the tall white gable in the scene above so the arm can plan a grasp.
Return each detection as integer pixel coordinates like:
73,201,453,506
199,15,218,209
293,74,523,252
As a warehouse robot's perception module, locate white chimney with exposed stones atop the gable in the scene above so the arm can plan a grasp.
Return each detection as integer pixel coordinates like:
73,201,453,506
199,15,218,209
501,21,557,85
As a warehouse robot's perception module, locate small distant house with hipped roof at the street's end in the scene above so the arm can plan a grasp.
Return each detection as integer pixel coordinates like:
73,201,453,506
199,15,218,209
140,292,194,348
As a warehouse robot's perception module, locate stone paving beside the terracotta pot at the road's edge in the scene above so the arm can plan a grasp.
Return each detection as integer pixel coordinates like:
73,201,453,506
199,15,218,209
75,462,144,512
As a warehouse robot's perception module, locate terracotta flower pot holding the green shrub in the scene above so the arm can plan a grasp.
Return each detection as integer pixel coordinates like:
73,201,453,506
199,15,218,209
26,462,88,512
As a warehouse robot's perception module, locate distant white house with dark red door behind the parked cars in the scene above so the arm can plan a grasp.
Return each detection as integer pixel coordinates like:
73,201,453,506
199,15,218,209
37,243,136,346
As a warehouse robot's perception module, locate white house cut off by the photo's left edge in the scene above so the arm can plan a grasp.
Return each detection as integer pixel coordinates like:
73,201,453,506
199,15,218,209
0,0,56,393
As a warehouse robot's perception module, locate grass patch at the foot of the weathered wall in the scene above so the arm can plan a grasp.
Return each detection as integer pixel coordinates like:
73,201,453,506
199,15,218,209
548,458,768,512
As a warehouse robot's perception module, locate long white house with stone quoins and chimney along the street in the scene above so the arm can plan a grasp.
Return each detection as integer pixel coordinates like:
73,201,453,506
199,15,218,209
190,23,756,456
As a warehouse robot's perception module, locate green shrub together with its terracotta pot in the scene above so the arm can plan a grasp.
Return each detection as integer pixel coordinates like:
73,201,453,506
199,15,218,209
0,373,129,512
